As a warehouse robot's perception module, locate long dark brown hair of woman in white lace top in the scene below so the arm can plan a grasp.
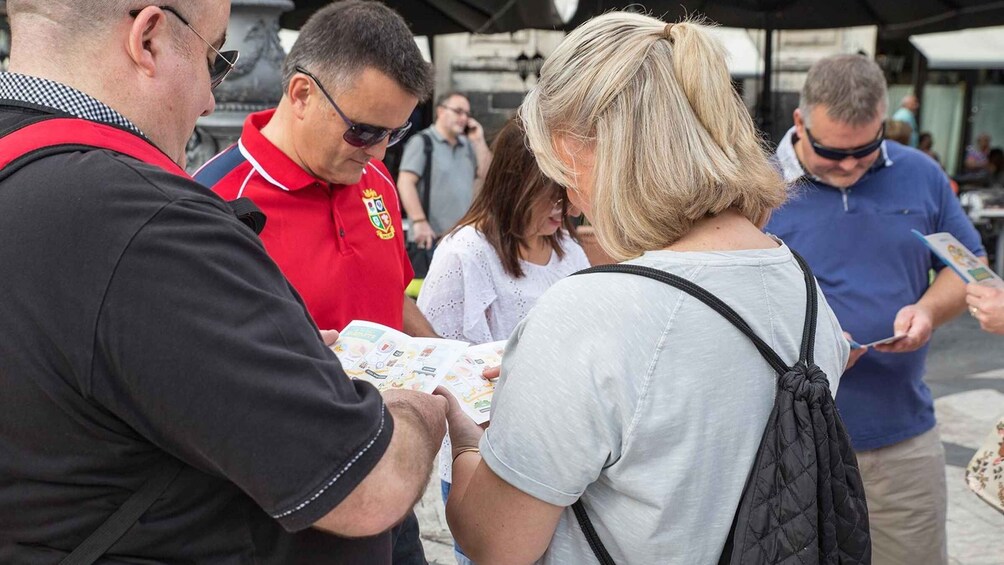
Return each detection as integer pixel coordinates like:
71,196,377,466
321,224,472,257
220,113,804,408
453,118,575,279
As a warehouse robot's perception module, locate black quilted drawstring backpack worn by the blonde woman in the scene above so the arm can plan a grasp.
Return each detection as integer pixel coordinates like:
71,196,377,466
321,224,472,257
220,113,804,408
572,254,871,565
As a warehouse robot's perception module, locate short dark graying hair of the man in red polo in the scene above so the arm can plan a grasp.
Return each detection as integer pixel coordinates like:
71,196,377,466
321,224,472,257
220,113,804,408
282,0,434,101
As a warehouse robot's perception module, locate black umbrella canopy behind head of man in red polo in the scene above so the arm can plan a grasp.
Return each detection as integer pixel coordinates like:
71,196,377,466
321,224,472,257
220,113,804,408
280,0,563,35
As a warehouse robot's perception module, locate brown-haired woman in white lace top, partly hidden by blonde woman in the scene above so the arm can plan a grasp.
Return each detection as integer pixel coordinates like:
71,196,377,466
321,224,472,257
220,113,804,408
419,120,589,564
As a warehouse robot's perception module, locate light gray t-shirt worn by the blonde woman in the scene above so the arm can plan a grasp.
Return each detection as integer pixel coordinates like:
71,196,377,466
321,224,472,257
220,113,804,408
481,245,848,565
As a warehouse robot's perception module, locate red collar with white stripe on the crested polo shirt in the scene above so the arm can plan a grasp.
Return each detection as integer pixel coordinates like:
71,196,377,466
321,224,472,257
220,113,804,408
237,108,327,192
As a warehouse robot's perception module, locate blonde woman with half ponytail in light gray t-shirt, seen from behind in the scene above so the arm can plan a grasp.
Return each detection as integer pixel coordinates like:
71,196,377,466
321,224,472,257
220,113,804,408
435,12,848,565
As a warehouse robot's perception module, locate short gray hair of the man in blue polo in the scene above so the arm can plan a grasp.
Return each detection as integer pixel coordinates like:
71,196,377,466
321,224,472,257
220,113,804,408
798,54,889,125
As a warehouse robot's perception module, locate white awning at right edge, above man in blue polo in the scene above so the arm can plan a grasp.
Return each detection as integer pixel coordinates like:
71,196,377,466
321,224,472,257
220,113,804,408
910,26,1004,69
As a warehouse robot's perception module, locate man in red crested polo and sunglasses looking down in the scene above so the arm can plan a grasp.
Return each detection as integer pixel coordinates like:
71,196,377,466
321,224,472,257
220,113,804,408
196,0,435,565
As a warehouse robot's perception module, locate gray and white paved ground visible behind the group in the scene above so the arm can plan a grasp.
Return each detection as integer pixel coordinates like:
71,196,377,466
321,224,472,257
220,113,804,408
416,316,1004,565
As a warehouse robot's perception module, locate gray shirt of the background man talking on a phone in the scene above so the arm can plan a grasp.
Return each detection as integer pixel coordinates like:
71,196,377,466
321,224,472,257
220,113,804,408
401,125,478,236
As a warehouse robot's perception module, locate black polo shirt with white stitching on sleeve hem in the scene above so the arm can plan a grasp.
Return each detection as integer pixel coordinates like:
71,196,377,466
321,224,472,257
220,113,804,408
0,105,393,564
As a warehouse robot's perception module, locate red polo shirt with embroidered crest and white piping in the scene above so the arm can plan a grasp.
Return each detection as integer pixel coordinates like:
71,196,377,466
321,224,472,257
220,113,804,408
195,110,413,330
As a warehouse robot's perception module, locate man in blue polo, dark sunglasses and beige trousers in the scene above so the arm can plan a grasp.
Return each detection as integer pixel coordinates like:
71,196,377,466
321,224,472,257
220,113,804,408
767,55,985,564
